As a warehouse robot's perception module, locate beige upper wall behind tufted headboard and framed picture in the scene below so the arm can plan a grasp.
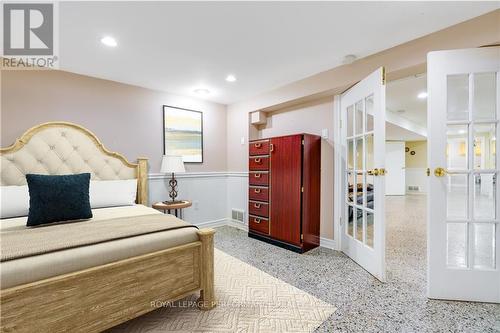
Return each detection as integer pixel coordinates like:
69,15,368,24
0,71,227,172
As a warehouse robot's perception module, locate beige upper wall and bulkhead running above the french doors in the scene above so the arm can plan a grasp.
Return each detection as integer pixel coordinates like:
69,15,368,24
227,10,500,171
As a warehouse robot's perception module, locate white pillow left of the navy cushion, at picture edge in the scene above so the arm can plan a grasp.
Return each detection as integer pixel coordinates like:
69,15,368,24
0,185,30,219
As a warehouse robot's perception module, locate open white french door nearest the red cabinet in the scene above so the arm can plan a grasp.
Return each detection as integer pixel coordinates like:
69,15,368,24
340,68,385,281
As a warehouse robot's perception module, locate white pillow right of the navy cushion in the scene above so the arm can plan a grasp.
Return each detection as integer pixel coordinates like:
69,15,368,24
89,179,137,208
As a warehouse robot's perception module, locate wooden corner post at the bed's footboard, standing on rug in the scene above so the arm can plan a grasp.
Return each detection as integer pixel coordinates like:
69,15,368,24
198,229,216,310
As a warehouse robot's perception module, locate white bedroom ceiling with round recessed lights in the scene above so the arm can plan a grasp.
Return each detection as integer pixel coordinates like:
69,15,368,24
59,2,499,104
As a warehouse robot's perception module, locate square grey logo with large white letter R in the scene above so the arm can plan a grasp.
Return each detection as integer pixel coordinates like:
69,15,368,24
3,3,54,56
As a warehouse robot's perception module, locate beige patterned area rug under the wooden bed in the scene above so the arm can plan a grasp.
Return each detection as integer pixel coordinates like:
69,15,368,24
109,249,335,333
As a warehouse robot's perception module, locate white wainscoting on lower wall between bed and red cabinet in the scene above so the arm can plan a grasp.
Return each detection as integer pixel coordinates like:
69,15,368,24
148,172,336,249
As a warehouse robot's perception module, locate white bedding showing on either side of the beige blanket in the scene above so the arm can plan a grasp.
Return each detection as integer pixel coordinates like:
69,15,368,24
0,205,198,289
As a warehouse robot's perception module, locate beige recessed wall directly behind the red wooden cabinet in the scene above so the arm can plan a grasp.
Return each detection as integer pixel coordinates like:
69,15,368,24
252,97,334,239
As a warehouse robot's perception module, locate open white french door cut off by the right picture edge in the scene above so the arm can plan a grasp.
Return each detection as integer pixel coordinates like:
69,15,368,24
427,47,500,303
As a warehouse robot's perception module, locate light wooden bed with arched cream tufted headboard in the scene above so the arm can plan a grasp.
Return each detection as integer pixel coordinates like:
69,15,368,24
0,122,215,332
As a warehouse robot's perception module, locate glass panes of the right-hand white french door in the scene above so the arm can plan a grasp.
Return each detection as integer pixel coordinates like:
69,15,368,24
446,72,498,270
